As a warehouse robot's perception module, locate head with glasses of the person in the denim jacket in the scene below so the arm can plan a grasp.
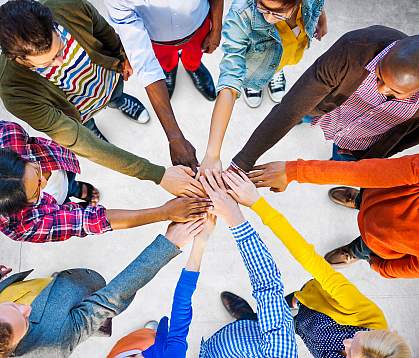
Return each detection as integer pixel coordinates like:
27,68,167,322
256,0,300,24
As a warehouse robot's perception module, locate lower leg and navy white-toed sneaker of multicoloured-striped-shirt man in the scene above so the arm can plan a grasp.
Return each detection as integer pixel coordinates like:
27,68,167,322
108,76,150,123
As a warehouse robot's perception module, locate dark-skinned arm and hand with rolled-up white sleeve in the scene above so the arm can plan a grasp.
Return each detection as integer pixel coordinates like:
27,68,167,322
106,0,198,170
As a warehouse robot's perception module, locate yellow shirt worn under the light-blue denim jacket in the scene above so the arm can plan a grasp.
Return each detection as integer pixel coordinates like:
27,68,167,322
275,5,308,72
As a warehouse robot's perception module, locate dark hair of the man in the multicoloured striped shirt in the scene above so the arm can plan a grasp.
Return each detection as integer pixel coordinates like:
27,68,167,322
0,0,56,60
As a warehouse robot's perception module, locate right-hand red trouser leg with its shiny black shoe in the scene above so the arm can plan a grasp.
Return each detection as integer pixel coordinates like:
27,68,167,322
180,17,216,101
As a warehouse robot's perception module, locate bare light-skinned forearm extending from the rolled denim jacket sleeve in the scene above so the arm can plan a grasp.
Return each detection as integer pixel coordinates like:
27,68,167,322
206,88,237,159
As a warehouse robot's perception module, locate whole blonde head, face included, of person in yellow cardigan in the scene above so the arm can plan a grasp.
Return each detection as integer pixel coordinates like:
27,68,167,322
343,330,413,358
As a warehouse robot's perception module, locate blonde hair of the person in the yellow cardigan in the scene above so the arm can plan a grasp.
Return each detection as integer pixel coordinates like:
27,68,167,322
359,330,413,358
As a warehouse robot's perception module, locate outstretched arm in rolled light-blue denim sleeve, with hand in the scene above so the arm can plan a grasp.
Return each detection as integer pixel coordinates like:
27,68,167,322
200,8,250,174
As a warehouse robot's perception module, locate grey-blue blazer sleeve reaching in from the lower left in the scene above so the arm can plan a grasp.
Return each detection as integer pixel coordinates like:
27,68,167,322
67,235,181,343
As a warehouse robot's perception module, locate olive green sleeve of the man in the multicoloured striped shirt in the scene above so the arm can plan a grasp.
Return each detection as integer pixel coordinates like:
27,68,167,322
3,91,165,184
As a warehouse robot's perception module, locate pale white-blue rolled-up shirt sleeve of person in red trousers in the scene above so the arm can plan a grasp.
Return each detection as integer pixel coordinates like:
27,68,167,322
105,0,165,87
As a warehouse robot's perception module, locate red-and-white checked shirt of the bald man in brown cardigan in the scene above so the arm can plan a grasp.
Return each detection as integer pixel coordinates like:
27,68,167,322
312,41,419,150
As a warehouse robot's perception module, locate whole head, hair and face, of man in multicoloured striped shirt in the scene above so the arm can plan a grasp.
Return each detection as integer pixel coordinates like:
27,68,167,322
0,0,64,68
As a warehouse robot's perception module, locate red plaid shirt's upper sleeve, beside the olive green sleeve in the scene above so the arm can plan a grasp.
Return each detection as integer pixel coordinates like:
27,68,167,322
0,121,80,174
